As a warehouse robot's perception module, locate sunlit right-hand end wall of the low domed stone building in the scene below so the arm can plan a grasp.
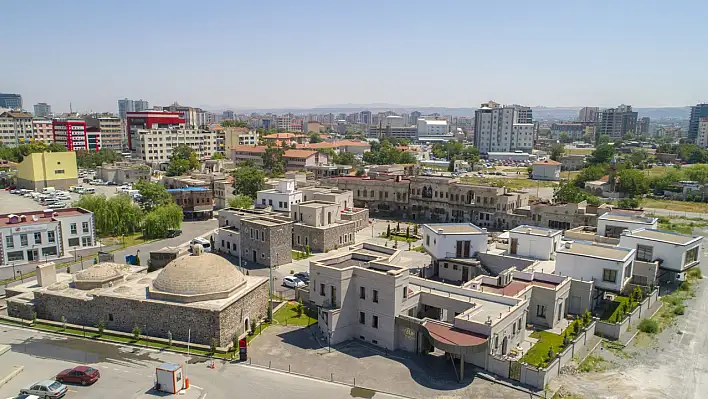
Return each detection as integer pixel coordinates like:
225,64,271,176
217,280,268,346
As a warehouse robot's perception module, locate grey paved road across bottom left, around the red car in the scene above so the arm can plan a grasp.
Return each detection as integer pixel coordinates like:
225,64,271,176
0,326,404,399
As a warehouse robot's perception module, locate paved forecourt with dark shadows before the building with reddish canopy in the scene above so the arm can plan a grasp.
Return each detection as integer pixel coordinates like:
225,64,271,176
248,325,529,399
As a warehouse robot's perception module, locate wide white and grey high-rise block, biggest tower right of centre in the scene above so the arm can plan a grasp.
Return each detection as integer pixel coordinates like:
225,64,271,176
474,101,535,153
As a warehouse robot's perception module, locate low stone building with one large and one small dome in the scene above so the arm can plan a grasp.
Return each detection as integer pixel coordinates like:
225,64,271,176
7,255,268,346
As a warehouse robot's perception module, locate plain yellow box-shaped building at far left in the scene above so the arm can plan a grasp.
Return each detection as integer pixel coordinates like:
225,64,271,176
17,151,79,191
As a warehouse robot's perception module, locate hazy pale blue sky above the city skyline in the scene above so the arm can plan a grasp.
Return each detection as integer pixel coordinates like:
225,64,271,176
0,0,708,112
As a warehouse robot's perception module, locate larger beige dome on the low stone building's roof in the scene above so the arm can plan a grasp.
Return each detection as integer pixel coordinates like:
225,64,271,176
152,253,245,299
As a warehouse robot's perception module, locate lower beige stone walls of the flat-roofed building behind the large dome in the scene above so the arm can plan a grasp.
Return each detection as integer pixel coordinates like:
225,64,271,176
293,222,355,252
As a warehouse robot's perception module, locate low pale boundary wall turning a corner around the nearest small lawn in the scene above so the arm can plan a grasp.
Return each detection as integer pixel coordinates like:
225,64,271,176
487,321,598,389
